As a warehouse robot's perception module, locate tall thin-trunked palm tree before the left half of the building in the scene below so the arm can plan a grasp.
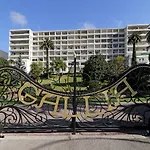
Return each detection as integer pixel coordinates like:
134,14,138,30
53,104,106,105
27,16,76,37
40,38,54,79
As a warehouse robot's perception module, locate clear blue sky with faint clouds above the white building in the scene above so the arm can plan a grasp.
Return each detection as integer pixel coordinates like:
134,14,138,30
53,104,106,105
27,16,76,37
0,0,150,52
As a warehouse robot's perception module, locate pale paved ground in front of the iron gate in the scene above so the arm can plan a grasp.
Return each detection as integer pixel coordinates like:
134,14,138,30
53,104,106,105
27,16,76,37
0,132,150,150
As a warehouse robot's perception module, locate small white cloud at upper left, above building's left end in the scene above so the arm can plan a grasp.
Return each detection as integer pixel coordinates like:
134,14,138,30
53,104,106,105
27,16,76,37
10,11,28,26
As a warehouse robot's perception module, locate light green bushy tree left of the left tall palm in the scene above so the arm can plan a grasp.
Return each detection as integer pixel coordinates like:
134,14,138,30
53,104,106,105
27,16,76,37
30,62,43,80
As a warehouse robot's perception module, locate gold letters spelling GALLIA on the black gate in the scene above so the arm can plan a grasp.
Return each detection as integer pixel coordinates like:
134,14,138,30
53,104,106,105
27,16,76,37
18,77,137,118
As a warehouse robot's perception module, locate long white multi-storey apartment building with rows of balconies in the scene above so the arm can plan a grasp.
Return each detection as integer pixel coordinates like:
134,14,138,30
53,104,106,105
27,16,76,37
9,24,149,72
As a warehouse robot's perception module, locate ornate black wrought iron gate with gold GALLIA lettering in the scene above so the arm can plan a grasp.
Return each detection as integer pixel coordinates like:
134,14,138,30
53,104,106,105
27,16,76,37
0,63,150,132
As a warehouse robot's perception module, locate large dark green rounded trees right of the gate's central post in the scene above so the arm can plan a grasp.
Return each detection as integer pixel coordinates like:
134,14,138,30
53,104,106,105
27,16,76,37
82,55,125,90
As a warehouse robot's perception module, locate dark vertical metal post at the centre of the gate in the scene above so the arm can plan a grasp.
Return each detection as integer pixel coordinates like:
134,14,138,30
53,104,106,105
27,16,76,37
72,54,77,134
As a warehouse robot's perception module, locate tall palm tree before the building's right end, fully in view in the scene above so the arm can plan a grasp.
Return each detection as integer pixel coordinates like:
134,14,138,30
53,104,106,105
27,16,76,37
128,32,141,65
